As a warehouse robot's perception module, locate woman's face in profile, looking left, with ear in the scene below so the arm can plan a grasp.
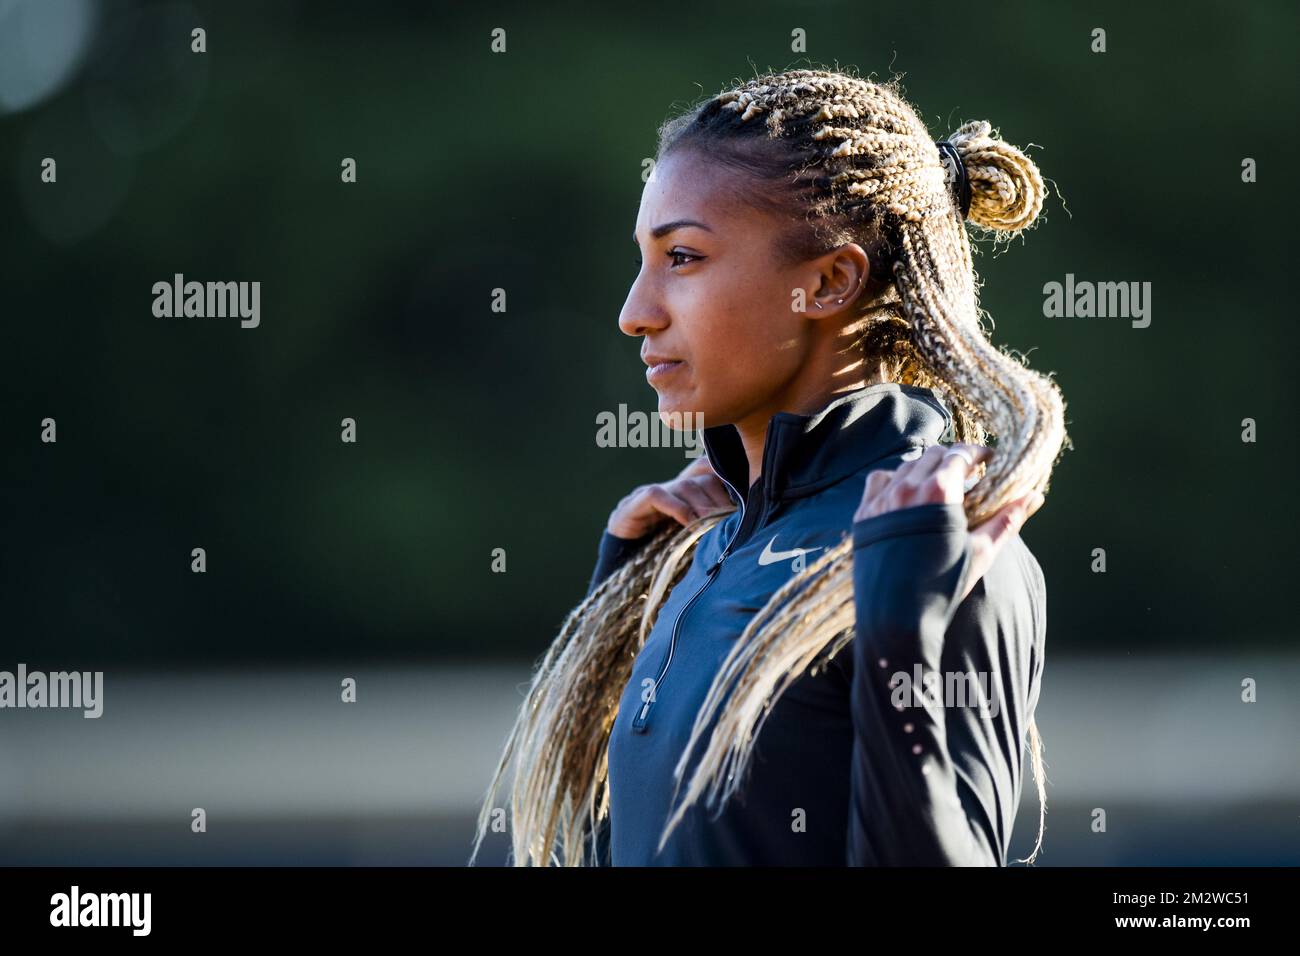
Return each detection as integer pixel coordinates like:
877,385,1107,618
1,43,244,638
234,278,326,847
619,150,866,428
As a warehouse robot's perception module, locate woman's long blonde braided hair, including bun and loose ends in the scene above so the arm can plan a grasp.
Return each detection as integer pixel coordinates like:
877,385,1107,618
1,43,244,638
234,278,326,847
471,69,1069,865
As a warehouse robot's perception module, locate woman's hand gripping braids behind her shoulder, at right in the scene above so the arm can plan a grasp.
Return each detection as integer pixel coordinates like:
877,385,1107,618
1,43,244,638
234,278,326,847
853,442,1043,601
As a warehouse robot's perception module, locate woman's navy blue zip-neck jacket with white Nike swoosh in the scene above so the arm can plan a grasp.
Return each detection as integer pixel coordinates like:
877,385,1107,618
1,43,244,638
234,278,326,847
589,382,1047,866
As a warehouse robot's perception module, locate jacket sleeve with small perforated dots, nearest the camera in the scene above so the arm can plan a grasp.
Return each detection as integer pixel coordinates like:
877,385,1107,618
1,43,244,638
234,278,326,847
846,502,1045,866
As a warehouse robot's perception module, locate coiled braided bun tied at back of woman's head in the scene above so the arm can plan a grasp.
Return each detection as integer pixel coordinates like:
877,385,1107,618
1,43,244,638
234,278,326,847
948,120,1045,233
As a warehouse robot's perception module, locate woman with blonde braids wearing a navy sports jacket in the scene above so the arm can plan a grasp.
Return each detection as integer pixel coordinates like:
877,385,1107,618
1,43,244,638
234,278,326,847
471,69,1066,865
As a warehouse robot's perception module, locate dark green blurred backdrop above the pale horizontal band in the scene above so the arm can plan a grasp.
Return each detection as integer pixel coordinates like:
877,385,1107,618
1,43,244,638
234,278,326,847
0,3,1300,670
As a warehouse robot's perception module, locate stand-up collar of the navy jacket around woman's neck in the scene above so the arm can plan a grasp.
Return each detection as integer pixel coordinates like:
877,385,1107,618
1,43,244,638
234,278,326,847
703,382,953,505
